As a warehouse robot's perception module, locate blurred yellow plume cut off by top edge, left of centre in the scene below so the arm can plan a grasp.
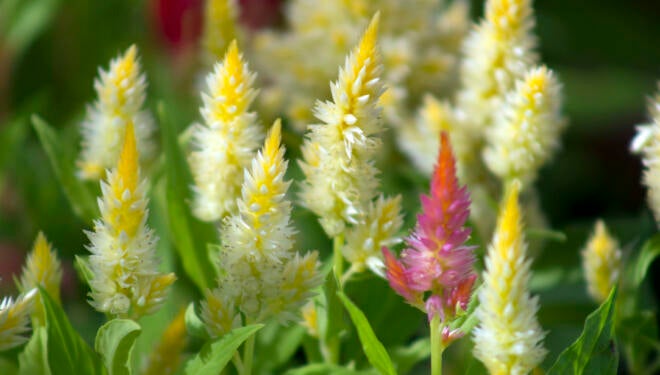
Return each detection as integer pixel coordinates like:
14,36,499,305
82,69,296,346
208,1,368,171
202,0,238,65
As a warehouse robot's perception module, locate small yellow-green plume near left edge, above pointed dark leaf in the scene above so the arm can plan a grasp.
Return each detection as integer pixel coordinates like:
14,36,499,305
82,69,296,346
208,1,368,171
18,232,62,324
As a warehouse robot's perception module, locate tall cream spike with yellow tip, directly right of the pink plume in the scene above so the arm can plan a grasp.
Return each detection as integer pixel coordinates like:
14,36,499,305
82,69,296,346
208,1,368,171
474,181,547,374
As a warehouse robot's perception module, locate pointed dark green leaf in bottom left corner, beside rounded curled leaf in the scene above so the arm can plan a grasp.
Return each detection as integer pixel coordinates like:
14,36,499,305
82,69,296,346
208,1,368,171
39,288,102,375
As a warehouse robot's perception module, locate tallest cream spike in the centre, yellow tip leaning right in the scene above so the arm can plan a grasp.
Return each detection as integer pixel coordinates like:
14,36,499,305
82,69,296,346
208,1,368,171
300,14,383,237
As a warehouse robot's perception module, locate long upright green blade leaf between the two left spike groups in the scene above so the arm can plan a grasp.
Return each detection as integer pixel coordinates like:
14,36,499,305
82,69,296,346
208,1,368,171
158,103,215,291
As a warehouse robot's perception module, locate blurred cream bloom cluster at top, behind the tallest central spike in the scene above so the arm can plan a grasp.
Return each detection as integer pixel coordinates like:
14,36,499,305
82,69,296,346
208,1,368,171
248,0,469,130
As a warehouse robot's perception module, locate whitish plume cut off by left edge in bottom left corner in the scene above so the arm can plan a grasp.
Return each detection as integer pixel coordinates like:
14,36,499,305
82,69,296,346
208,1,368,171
0,289,37,351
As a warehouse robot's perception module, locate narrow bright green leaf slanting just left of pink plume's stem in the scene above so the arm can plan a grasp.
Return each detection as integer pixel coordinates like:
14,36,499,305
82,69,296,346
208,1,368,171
337,292,396,375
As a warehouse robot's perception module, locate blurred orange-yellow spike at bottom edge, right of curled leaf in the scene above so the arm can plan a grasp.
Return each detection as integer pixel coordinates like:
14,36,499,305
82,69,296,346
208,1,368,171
142,309,188,375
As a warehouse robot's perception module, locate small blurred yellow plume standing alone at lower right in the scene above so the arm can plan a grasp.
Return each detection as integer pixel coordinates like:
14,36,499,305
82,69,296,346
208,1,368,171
582,220,621,303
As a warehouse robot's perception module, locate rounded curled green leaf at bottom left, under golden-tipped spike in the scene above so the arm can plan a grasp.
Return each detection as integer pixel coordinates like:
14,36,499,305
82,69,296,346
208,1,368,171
94,319,142,375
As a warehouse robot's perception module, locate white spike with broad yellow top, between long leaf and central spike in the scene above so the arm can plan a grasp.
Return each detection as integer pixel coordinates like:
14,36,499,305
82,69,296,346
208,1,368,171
189,41,263,221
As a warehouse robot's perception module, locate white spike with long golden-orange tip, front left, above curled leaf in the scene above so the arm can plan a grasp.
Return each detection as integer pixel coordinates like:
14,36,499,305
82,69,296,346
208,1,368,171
86,122,176,319
